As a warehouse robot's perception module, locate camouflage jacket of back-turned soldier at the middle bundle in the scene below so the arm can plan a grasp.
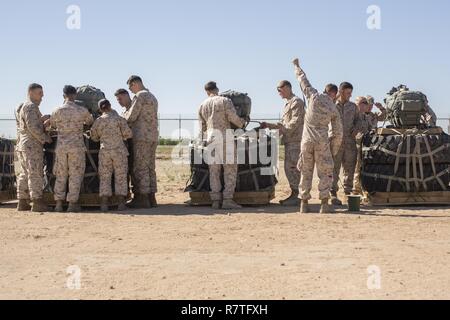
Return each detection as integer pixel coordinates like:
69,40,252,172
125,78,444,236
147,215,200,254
198,96,245,142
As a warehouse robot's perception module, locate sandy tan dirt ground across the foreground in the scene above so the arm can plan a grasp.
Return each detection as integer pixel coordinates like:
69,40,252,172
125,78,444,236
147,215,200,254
0,156,450,299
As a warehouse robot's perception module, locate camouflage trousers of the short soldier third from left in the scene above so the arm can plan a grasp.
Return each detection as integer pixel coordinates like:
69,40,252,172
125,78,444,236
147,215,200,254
98,149,128,197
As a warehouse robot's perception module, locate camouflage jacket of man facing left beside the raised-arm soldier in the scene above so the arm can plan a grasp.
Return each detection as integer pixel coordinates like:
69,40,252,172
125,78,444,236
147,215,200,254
281,95,305,143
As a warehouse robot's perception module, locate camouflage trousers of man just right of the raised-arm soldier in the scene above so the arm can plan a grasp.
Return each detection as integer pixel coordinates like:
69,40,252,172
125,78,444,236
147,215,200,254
331,140,358,194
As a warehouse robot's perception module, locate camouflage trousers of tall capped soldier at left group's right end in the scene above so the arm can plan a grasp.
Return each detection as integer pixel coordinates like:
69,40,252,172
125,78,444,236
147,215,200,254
131,141,158,194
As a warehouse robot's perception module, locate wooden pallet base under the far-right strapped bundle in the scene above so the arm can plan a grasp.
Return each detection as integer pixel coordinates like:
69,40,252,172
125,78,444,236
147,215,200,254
367,191,450,206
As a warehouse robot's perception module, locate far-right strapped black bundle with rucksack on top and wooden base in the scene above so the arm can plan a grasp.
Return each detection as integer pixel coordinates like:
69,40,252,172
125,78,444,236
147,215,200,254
361,86,450,205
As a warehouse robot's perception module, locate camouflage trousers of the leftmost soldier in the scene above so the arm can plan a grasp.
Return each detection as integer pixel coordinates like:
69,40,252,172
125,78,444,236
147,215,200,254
17,147,44,200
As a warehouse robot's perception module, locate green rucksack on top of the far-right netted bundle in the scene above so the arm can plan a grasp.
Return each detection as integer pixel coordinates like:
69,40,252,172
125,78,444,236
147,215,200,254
385,87,428,128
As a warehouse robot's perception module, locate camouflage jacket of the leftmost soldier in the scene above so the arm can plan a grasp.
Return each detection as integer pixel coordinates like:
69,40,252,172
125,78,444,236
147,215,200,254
16,101,47,151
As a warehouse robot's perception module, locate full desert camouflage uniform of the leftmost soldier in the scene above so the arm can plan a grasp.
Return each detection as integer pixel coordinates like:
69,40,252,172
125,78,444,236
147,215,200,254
16,101,48,200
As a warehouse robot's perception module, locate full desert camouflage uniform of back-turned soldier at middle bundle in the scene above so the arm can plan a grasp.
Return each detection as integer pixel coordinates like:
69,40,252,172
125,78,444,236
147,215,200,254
199,96,245,201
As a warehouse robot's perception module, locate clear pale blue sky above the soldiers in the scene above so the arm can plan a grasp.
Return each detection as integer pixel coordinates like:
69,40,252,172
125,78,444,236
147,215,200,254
0,0,450,136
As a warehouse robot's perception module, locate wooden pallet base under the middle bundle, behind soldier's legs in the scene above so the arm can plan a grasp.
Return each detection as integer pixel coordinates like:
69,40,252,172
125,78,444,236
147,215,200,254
189,190,275,206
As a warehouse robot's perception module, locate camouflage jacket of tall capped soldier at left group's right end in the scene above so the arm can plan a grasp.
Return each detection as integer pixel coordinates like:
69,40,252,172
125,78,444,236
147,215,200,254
123,90,159,142
